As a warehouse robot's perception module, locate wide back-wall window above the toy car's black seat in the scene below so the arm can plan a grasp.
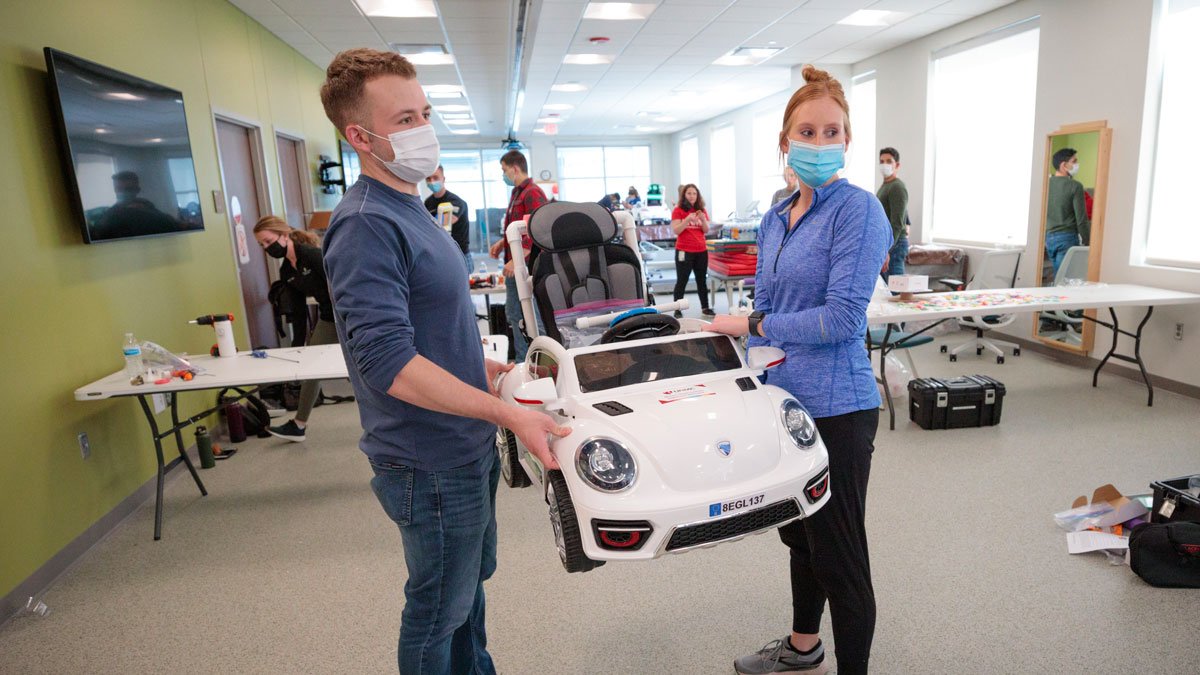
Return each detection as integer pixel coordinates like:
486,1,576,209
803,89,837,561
558,145,650,202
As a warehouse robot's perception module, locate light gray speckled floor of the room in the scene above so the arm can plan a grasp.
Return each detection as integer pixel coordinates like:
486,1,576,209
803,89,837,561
0,298,1200,674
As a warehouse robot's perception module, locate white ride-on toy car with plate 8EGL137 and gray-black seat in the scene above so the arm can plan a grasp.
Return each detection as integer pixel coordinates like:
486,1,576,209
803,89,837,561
497,202,829,572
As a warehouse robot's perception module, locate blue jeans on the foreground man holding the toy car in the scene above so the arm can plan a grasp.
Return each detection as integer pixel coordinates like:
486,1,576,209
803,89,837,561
371,452,500,675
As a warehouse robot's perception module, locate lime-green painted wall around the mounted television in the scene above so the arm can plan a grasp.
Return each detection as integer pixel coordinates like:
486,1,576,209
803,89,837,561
0,0,337,596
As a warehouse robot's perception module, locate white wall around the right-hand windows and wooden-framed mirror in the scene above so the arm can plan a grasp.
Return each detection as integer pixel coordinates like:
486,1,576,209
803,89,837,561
853,0,1200,386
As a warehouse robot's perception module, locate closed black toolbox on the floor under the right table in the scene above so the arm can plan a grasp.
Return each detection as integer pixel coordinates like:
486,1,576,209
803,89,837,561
908,375,1004,429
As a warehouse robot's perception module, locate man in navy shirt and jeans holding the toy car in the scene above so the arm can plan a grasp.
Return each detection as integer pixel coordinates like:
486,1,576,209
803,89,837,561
320,49,568,674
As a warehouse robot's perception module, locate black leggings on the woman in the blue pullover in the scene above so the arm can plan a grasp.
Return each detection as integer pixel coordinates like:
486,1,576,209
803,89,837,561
779,408,880,674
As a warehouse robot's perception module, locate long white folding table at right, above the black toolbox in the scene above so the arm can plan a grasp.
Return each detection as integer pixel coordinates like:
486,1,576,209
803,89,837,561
866,283,1200,429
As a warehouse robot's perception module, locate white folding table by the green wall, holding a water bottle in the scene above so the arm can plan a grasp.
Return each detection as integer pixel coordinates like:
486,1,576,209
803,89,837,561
74,345,348,540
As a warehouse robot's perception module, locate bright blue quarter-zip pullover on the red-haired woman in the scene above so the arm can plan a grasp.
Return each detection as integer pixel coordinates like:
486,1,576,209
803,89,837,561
750,179,892,417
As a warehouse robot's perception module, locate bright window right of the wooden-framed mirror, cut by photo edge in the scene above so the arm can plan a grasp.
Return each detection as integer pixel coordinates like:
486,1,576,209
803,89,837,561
1145,0,1200,268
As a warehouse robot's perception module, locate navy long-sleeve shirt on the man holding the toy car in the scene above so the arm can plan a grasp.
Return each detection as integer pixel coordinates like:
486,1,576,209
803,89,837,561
324,177,496,471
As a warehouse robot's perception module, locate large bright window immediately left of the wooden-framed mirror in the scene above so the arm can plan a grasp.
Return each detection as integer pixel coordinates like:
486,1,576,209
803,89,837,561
926,22,1039,245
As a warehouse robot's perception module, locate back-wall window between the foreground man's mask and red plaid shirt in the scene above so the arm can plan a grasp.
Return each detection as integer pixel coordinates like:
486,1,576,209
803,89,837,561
421,148,532,253
